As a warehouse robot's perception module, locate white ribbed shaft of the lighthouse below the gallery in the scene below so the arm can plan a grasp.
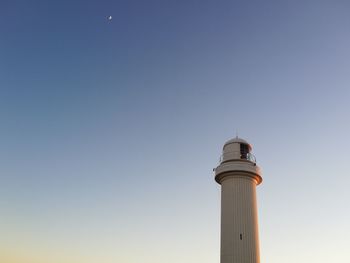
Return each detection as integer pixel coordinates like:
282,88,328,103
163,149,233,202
220,175,260,263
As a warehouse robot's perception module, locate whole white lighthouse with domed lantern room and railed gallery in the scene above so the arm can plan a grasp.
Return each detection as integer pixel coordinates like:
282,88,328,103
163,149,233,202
214,137,262,263
